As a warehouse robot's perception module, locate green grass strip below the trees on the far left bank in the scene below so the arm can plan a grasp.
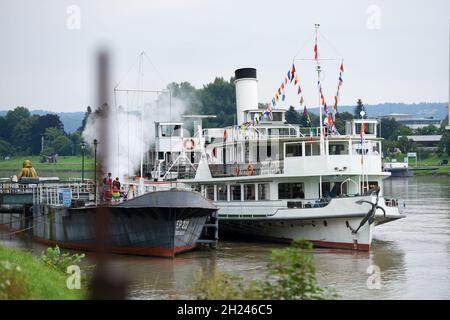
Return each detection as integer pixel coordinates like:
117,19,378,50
0,156,94,180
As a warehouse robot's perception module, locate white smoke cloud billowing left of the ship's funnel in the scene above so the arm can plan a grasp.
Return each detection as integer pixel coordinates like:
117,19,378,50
83,94,190,181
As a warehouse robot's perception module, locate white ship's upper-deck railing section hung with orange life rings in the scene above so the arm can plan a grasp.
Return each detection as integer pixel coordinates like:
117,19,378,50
209,160,284,178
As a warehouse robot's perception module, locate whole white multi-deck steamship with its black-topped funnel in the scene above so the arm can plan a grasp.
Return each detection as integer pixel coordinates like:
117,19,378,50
145,68,404,250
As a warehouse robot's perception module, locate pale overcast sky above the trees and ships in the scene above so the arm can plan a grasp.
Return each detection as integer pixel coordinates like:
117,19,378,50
0,0,450,111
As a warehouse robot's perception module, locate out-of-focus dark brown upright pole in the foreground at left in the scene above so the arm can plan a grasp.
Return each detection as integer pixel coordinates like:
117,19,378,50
90,50,127,300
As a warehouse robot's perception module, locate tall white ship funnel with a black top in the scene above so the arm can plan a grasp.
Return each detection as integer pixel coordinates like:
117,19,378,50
234,68,258,125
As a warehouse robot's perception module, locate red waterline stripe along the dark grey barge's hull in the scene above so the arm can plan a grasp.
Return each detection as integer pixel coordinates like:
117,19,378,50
29,236,195,258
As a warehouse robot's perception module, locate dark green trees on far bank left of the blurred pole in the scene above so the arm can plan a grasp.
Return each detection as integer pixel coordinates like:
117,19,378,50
0,107,91,157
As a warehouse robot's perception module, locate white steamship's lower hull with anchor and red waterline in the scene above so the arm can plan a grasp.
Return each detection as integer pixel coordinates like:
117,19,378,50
218,197,404,251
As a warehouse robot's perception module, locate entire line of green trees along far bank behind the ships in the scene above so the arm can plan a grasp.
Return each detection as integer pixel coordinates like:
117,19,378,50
0,77,450,157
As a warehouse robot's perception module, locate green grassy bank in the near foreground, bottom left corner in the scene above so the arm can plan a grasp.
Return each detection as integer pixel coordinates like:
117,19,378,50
0,246,85,300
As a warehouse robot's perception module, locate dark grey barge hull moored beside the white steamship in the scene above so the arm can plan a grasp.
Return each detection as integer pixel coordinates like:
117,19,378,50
0,190,216,257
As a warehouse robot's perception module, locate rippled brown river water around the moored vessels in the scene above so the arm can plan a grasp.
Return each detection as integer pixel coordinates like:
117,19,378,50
0,177,450,299
